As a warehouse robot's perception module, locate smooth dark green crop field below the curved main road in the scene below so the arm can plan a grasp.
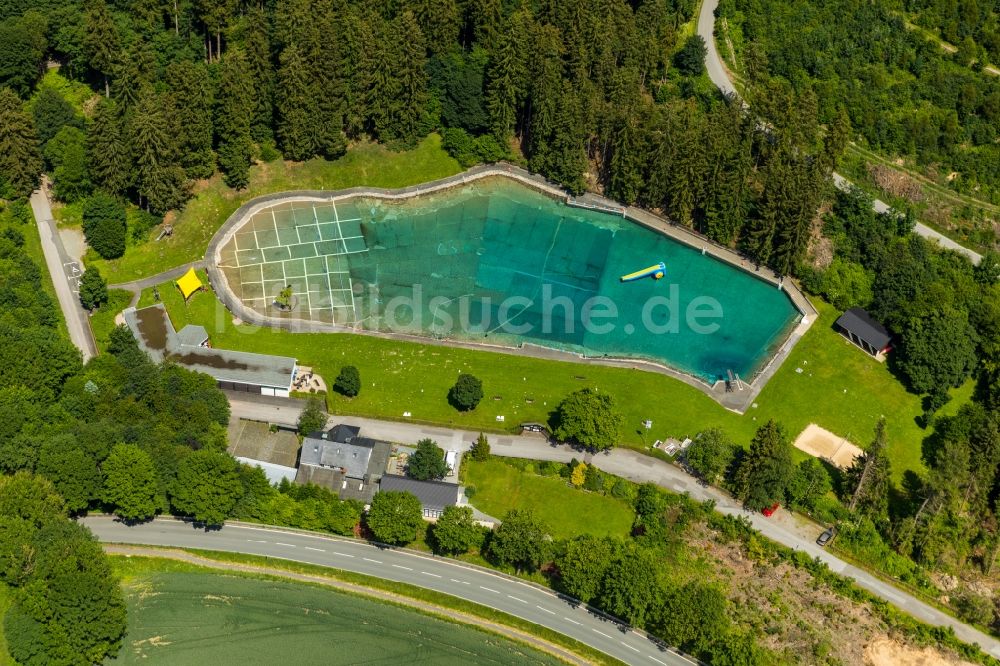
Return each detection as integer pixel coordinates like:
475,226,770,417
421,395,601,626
113,558,558,666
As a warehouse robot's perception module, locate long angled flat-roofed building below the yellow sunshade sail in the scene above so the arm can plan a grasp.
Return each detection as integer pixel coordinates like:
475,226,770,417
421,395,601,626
123,303,297,398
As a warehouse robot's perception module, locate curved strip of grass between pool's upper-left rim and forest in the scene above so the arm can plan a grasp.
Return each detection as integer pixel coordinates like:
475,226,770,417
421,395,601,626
86,134,461,284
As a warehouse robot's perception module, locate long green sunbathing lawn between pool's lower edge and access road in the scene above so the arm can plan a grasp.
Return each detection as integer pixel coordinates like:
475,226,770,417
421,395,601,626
141,268,971,479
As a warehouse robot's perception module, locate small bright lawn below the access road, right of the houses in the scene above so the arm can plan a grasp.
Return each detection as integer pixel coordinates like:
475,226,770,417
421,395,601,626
461,457,635,538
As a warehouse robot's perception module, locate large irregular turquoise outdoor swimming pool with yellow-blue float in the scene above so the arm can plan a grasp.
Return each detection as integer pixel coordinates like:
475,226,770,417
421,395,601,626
218,176,800,382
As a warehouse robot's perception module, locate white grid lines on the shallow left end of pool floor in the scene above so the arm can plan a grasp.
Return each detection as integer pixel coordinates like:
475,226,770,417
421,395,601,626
219,202,367,323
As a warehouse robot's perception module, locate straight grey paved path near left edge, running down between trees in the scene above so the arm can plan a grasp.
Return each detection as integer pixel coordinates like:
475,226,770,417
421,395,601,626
31,184,97,363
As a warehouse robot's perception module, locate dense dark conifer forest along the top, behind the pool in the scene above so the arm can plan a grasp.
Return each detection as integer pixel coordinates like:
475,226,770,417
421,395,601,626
0,0,845,274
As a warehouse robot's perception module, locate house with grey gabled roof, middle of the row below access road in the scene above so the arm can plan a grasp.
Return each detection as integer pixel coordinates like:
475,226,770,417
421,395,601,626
295,424,392,504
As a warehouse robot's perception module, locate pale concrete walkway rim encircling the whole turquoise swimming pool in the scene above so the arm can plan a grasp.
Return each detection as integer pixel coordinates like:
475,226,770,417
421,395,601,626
205,164,817,414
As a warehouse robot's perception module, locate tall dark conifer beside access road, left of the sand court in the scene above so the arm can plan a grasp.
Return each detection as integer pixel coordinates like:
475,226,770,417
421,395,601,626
735,420,795,511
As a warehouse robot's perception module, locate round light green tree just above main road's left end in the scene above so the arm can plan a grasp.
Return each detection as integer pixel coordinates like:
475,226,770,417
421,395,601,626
100,444,159,521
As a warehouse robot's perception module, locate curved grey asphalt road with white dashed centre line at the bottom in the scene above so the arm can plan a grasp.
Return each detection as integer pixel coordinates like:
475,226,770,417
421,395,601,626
80,516,696,666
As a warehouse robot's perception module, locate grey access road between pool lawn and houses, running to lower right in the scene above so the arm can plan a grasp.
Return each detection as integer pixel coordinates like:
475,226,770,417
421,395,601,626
229,394,1000,658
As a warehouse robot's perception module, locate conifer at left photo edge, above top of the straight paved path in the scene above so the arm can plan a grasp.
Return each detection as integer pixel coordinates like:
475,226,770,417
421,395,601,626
0,88,42,199
